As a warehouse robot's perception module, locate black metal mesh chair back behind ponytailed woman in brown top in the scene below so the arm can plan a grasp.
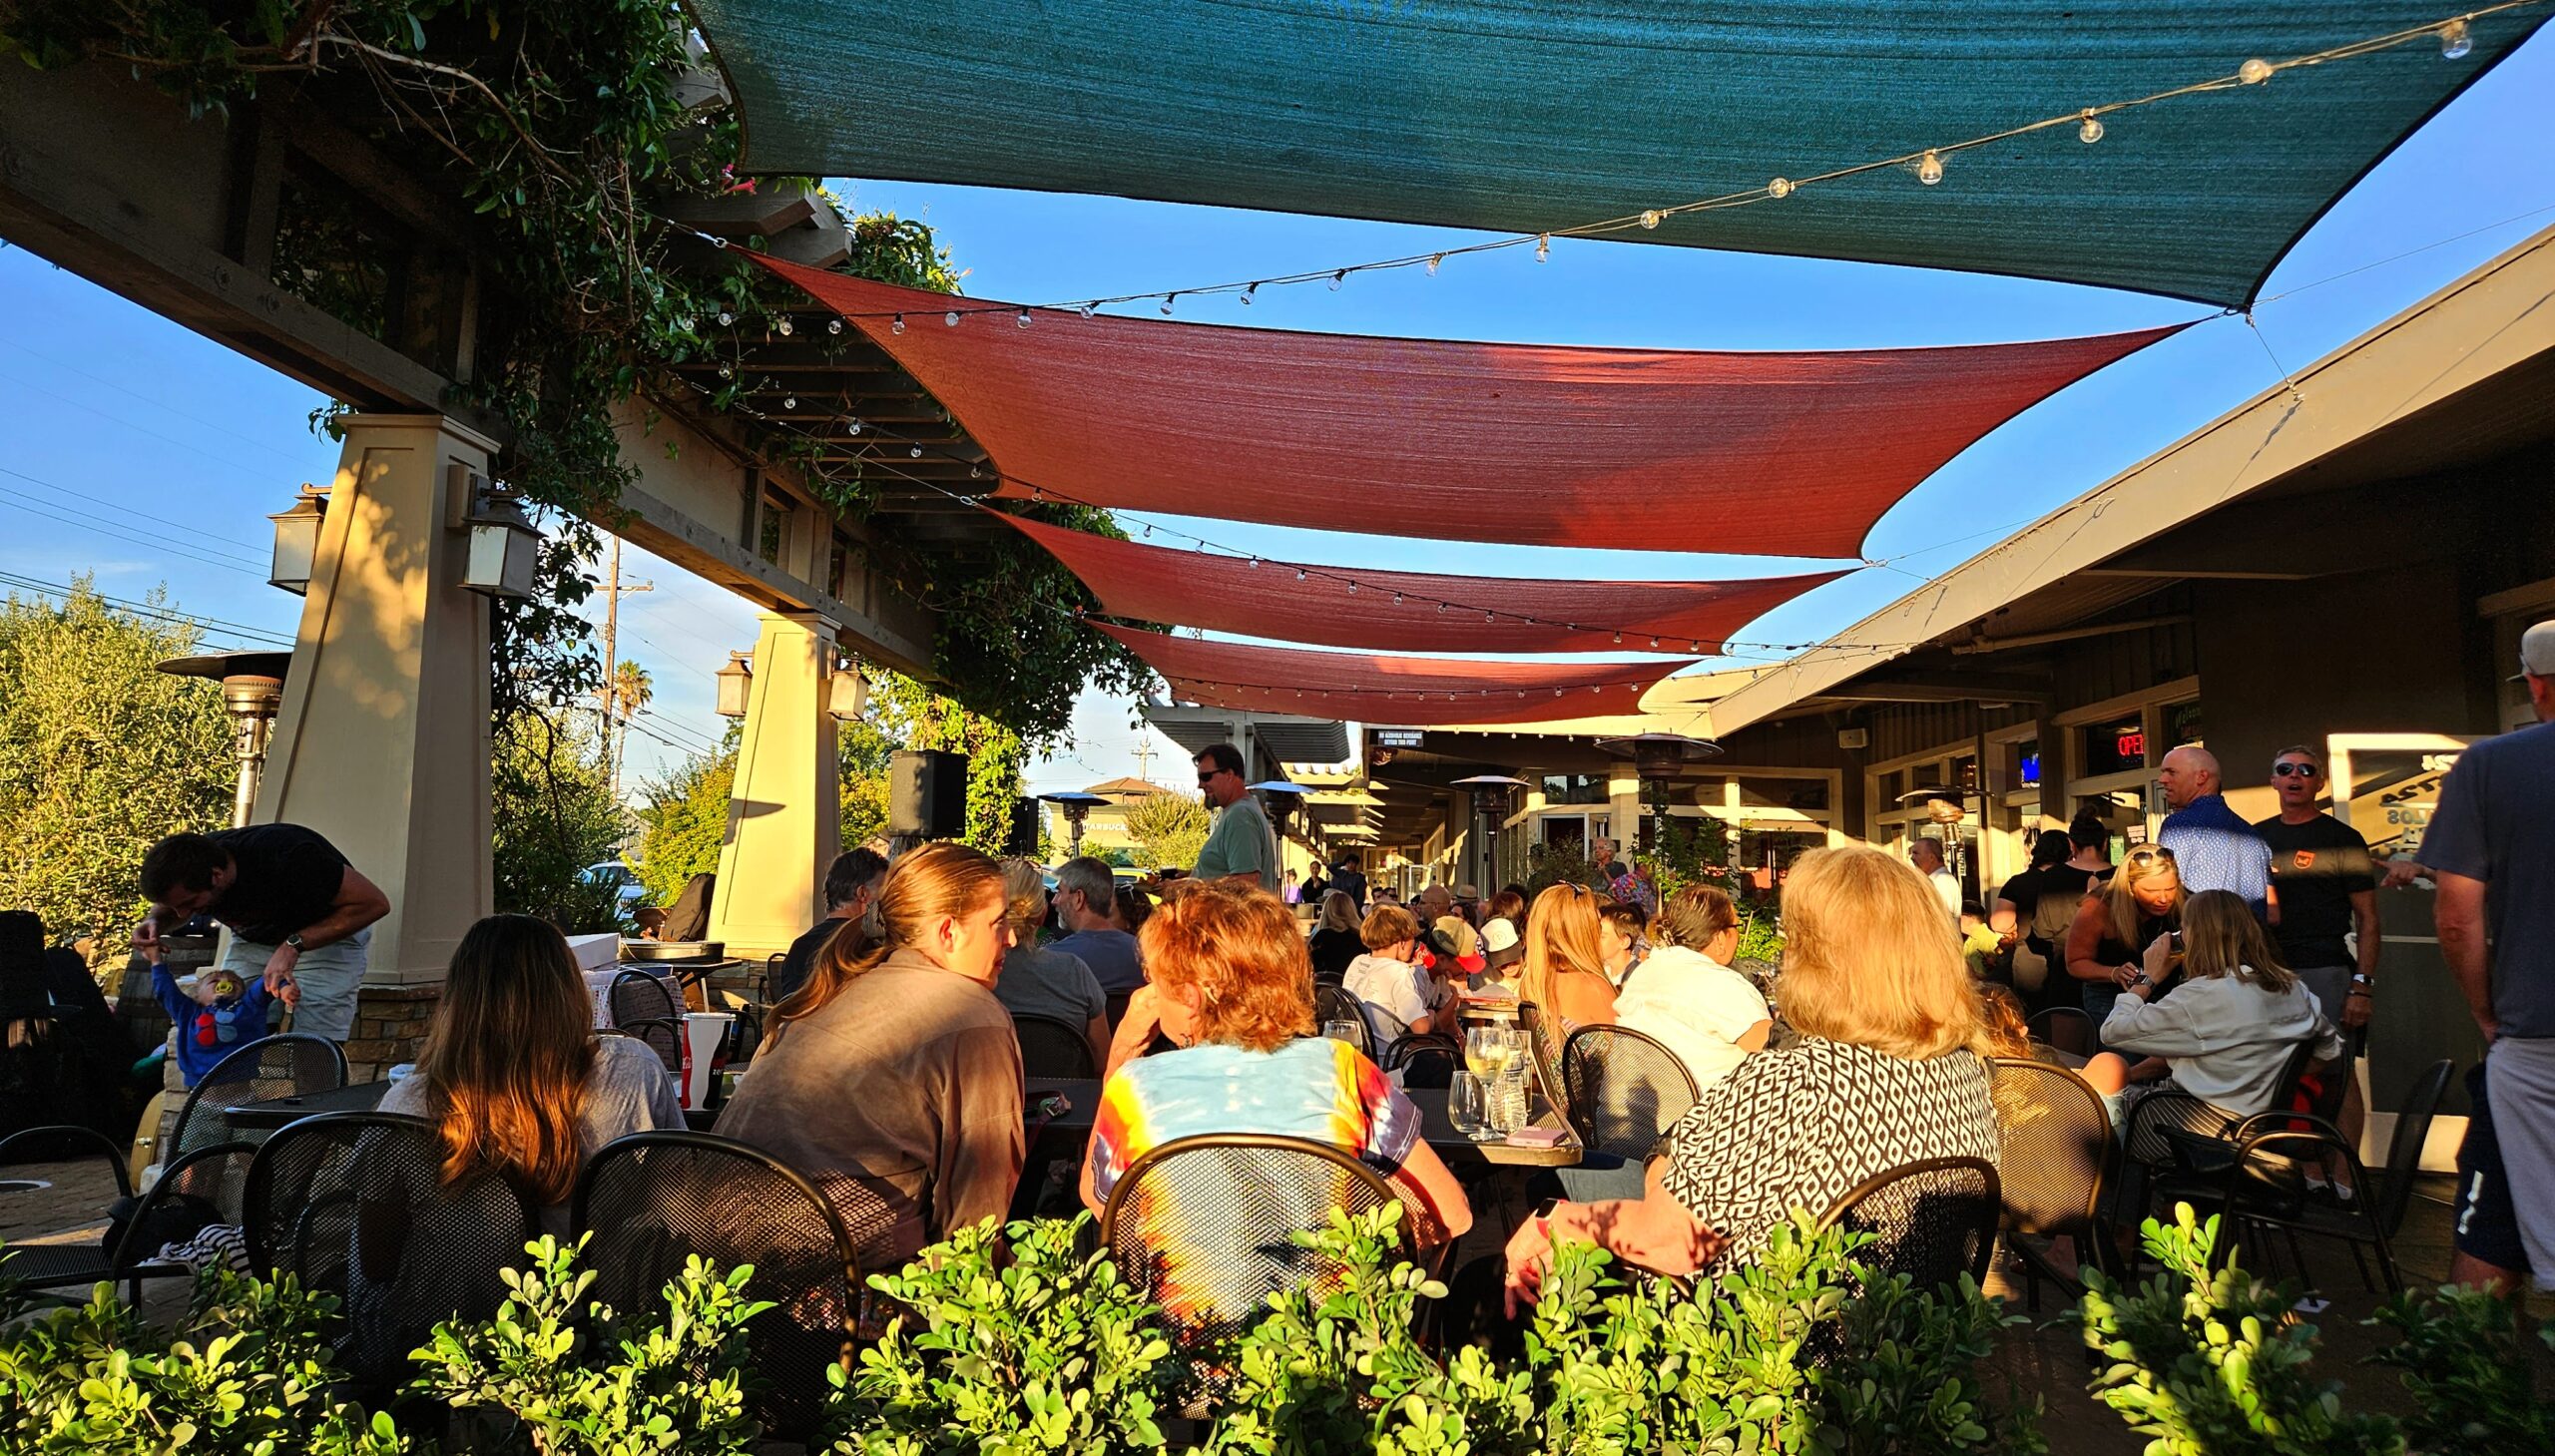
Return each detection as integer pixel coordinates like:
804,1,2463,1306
570,1132,861,1441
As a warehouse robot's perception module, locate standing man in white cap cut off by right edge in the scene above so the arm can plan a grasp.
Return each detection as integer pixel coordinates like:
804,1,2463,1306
2389,621,2555,1290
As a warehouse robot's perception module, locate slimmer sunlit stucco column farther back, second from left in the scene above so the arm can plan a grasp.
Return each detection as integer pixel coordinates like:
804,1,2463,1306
711,613,843,958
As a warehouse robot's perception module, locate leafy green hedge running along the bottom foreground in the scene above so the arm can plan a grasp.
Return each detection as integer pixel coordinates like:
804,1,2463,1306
0,1209,2555,1456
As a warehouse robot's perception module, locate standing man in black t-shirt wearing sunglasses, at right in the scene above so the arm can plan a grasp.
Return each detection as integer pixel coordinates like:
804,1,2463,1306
2254,745,2378,1032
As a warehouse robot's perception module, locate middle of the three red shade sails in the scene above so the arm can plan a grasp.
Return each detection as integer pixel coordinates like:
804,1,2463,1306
1002,516,1844,652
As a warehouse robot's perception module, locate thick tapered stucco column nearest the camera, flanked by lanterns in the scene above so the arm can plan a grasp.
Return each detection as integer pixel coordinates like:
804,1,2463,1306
253,414,496,986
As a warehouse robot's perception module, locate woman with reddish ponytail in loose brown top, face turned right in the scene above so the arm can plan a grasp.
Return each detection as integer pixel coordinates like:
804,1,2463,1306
718,843,1022,1269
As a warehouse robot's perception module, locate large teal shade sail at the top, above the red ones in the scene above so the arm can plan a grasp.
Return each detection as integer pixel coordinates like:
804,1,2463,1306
695,0,2547,306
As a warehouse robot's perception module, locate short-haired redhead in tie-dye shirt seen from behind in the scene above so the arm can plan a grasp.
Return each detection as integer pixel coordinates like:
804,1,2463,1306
1083,881,1472,1241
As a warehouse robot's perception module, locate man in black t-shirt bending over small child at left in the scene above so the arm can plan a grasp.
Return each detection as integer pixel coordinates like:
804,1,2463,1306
133,825,391,1042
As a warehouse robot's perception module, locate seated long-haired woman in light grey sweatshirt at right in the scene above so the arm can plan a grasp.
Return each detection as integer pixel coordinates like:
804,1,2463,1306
2103,889,2343,1117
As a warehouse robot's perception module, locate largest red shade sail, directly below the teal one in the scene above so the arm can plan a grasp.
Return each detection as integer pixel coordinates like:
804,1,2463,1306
747,252,2177,557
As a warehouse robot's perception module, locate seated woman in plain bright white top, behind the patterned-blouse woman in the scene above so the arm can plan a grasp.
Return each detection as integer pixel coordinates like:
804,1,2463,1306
1615,884,1774,1091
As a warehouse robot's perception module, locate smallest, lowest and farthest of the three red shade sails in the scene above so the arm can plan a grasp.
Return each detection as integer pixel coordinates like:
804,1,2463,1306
1091,624,1694,728
